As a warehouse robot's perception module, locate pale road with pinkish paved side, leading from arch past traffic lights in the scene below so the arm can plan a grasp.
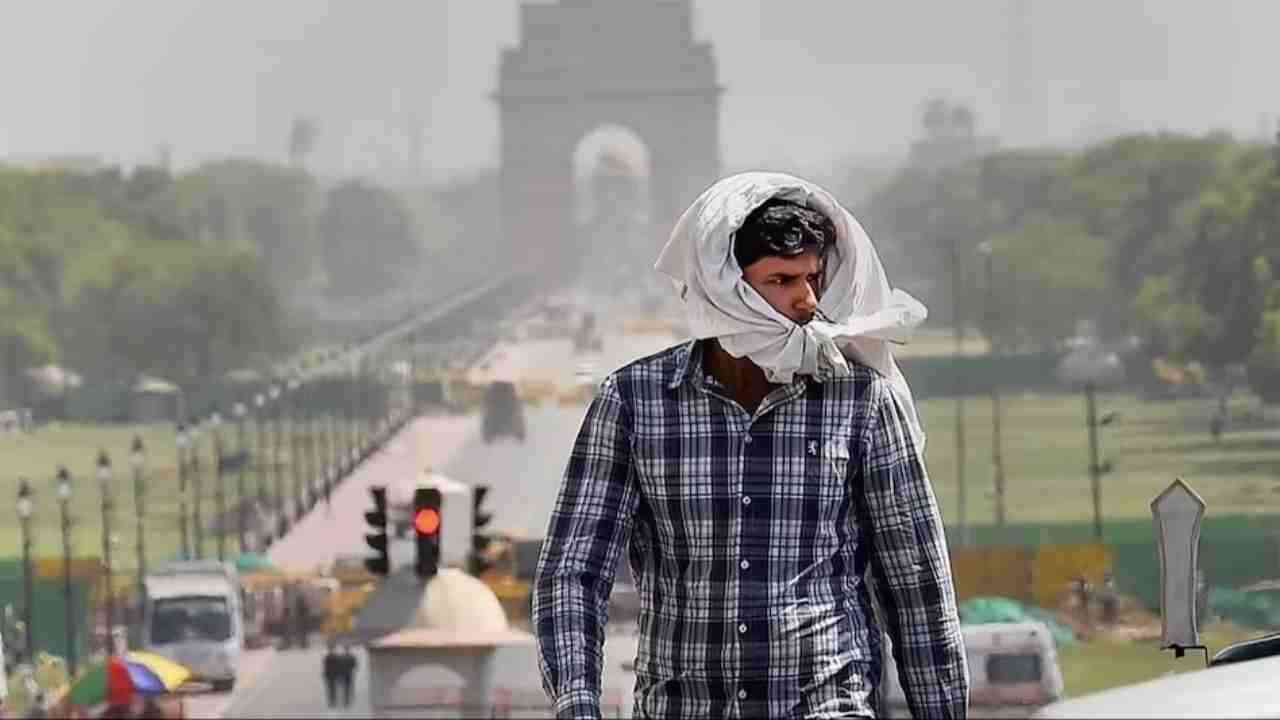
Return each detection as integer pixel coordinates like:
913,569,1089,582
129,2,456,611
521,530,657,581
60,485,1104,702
204,322,673,717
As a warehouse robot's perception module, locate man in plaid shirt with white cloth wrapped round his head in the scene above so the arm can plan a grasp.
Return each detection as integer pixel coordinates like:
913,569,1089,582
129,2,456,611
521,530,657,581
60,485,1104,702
534,173,969,717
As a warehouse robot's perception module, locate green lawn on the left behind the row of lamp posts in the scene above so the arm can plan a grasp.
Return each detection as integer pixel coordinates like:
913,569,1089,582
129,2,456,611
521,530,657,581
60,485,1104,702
0,423,343,574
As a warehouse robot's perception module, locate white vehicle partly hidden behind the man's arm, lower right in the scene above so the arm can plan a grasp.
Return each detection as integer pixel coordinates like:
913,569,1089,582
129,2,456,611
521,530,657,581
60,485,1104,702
884,621,1062,717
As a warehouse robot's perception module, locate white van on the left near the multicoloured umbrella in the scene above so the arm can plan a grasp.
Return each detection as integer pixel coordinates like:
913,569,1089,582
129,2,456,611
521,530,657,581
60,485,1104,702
142,560,244,691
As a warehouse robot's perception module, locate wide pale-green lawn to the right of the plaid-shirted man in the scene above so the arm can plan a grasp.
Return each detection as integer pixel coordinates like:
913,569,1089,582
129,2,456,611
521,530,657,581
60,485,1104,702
920,395,1280,524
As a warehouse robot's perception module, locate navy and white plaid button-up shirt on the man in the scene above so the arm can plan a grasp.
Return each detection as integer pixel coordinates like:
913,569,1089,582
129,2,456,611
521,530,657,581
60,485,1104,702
532,342,969,719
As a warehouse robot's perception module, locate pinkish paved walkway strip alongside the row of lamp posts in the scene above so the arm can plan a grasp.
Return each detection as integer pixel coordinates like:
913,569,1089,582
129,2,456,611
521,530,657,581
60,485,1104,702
268,415,477,571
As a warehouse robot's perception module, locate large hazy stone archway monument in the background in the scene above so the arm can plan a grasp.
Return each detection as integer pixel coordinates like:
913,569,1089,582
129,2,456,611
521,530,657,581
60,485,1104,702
495,0,723,279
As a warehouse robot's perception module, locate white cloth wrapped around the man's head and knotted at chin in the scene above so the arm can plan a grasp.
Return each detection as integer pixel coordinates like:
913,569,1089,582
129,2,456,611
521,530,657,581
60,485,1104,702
654,172,928,448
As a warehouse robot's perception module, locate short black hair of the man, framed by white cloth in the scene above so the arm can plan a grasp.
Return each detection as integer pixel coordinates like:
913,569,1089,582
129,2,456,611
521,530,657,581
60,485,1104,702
733,199,836,270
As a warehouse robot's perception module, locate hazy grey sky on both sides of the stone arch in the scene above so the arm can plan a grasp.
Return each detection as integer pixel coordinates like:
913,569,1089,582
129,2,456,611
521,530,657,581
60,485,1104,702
0,0,1280,177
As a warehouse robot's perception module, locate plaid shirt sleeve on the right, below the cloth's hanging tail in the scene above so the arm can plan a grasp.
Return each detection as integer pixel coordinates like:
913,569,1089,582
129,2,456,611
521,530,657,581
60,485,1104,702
860,379,969,719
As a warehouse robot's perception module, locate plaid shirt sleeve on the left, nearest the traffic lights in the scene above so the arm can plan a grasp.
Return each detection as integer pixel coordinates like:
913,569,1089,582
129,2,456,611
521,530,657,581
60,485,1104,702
532,375,640,719
